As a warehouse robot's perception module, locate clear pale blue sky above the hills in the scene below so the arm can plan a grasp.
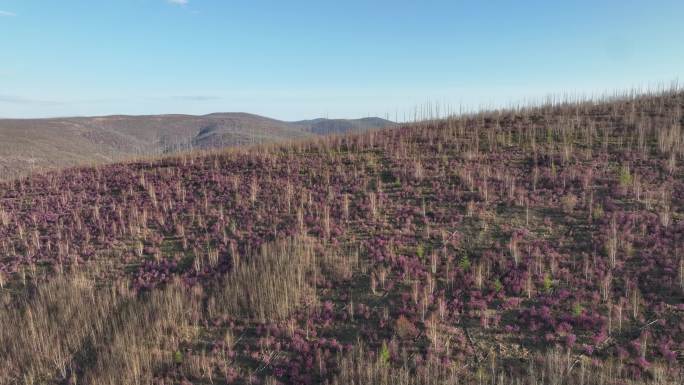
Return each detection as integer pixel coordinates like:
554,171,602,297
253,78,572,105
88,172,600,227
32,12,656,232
0,0,684,120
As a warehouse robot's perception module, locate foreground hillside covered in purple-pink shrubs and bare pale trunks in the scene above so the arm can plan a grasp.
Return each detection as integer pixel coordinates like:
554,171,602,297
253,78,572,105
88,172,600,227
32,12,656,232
0,92,684,385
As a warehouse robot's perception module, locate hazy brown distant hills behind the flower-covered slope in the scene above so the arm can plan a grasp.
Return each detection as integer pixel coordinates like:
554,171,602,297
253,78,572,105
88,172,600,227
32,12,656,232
0,113,393,179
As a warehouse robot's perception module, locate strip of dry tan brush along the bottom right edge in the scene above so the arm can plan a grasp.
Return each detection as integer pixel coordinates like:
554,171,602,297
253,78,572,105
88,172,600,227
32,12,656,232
329,342,684,385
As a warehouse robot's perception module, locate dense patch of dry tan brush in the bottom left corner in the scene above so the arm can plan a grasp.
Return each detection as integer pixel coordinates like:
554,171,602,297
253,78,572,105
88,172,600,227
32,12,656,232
0,274,198,385
